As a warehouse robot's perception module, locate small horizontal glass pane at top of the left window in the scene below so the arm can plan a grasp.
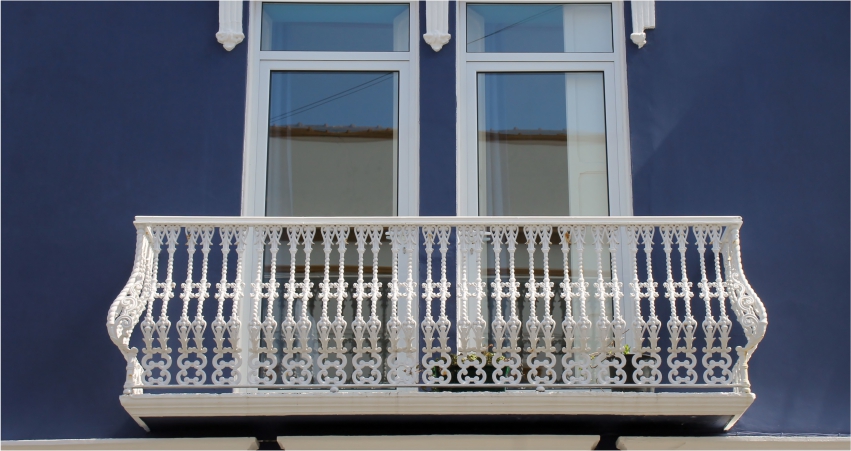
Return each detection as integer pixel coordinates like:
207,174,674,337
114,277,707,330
260,3,409,52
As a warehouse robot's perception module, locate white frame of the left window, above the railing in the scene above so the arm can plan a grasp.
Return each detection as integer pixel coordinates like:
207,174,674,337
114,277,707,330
241,0,420,216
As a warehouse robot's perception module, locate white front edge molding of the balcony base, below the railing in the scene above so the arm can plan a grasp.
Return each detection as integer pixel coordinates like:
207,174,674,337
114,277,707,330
120,390,756,430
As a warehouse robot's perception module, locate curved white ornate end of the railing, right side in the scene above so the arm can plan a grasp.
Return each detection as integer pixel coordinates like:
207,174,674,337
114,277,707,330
724,227,768,393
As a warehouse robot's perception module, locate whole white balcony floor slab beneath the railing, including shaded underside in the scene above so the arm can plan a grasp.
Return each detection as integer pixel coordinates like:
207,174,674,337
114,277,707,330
120,390,755,433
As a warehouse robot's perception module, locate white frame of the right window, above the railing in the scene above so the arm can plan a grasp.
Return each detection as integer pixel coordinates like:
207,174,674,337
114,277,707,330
455,0,632,216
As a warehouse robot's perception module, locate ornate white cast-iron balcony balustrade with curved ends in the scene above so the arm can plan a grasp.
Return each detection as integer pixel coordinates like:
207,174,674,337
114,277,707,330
107,217,767,427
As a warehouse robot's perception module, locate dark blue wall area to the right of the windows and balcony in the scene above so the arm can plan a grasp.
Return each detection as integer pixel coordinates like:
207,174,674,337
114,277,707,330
626,2,851,434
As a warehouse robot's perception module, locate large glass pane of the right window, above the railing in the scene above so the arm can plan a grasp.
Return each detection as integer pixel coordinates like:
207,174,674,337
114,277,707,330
477,72,609,216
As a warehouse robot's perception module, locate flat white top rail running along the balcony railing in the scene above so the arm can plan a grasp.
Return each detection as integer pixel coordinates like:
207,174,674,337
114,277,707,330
134,216,742,227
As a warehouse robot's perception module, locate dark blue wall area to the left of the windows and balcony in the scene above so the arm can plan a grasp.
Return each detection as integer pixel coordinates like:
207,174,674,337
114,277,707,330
0,2,247,440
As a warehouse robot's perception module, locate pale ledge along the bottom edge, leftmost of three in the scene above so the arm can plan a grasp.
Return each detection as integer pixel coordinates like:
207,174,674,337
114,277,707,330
0,437,258,450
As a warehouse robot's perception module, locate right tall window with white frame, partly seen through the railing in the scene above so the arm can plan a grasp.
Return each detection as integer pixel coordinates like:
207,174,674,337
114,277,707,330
458,2,632,349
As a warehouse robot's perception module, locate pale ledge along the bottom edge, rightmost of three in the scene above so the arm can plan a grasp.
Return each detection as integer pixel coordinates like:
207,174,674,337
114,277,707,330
617,436,851,450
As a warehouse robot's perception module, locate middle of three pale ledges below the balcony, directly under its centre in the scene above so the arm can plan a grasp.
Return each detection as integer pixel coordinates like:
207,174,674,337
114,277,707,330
278,435,600,451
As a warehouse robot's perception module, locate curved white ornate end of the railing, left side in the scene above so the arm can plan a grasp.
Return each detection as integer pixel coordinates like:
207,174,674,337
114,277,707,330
106,228,150,395
